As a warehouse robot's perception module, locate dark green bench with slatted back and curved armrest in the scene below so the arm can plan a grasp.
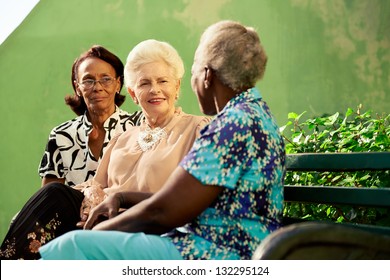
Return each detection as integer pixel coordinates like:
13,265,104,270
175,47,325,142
253,152,390,259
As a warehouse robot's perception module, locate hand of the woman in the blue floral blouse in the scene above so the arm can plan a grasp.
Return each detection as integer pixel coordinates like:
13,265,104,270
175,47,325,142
84,194,121,229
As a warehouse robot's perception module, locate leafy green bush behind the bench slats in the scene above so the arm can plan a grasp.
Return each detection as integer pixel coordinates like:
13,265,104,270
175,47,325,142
280,105,390,226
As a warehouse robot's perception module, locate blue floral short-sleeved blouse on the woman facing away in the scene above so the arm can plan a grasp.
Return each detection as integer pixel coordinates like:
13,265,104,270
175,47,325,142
171,88,285,259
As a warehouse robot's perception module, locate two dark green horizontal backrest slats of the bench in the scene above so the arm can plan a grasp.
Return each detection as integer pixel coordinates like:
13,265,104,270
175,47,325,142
284,152,390,208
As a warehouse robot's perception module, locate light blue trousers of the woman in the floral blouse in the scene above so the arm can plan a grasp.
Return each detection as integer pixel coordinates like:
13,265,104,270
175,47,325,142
39,230,183,260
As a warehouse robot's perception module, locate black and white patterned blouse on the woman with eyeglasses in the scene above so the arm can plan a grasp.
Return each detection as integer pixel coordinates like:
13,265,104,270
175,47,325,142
38,107,142,186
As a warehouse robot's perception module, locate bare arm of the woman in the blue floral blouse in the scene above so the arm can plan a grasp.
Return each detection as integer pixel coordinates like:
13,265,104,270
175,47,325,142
85,167,223,234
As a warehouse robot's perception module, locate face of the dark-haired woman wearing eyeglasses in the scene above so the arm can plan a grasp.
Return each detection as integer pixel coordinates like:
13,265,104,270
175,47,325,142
75,57,120,114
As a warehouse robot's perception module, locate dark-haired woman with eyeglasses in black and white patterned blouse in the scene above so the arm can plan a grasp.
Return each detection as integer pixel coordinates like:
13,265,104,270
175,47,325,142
39,45,142,186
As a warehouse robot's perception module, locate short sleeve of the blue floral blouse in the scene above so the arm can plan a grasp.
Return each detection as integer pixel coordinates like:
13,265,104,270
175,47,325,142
180,110,251,189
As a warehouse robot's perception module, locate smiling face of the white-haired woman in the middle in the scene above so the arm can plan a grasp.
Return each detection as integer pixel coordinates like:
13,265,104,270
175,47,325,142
128,61,180,127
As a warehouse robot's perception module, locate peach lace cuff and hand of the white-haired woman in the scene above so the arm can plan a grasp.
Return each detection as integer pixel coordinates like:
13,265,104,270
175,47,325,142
77,186,107,227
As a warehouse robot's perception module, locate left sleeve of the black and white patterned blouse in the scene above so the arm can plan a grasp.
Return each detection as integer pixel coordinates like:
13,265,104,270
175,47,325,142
38,129,65,178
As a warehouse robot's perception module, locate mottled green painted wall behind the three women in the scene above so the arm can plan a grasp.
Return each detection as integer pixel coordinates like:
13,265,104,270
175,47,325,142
0,0,390,239
